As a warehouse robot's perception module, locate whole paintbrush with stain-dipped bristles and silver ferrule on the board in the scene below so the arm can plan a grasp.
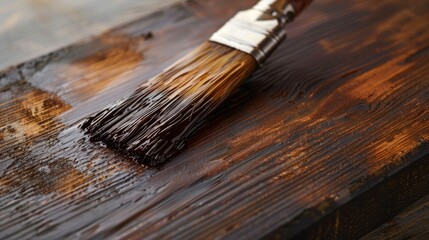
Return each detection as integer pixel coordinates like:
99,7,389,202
81,0,311,165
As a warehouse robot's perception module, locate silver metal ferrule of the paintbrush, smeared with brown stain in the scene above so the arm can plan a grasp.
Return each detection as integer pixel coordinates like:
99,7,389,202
210,0,294,63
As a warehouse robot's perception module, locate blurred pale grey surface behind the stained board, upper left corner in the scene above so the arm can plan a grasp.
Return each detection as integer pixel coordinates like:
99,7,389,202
0,0,181,69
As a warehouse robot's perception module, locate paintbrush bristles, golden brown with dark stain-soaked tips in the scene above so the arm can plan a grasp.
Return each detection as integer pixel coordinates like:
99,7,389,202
82,42,257,165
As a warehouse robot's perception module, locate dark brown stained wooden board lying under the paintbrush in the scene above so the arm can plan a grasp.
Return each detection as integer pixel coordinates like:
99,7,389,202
0,0,429,239
